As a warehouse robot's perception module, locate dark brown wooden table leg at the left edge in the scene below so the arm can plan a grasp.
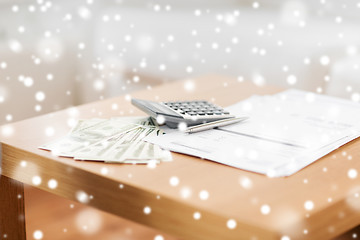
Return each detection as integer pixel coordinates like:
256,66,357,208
0,175,26,240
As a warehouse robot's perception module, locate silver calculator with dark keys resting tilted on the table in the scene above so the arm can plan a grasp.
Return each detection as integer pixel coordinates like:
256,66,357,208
131,98,235,128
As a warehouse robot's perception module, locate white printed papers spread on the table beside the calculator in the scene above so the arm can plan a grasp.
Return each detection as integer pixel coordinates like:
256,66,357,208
145,90,360,177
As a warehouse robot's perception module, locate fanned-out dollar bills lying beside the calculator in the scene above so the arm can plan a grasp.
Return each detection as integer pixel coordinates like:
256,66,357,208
39,117,172,164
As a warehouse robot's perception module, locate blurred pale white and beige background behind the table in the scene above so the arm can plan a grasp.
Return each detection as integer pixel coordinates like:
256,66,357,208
0,0,360,124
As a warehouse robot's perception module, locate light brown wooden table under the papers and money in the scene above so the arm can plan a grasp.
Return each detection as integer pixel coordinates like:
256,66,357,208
0,76,360,240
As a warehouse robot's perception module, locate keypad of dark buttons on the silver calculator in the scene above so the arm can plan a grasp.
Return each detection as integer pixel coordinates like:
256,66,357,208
164,101,230,117
